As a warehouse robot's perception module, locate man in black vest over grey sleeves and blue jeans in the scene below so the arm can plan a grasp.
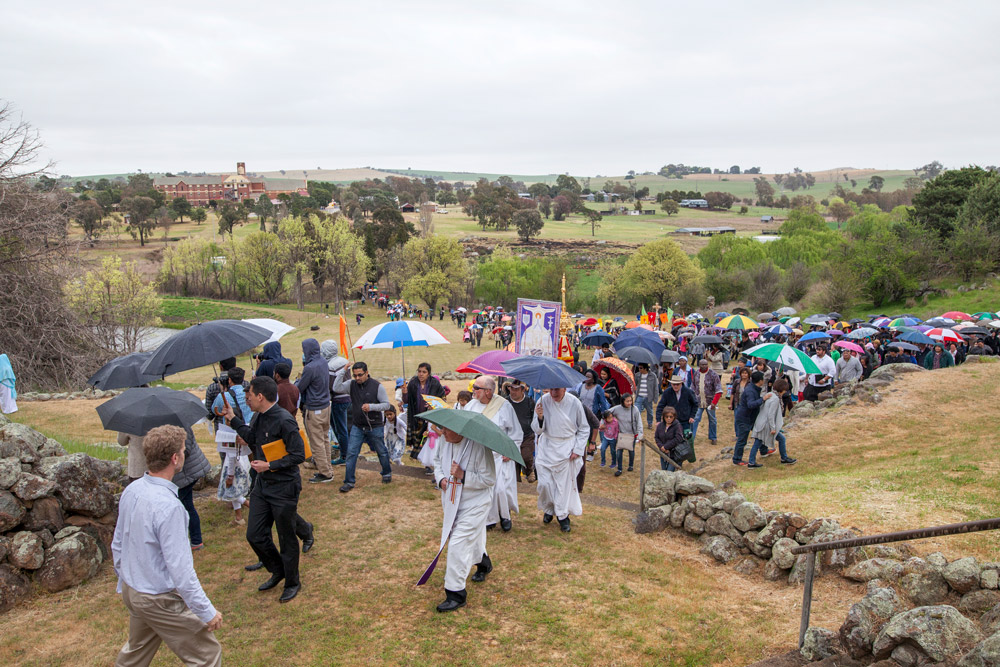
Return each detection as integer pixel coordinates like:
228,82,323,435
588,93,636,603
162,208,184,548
333,361,390,493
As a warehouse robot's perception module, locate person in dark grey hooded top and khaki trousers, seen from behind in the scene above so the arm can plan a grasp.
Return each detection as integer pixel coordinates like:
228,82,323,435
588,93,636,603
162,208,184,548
295,338,333,484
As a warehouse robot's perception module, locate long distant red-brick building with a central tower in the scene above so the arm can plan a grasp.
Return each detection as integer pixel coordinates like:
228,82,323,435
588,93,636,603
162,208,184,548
153,162,308,206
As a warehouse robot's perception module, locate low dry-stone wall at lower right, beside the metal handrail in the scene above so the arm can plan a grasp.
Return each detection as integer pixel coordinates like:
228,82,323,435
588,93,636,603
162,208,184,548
634,470,1000,667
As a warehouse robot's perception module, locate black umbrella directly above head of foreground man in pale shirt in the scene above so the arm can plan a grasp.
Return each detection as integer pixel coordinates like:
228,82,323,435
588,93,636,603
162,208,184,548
97,387,208,435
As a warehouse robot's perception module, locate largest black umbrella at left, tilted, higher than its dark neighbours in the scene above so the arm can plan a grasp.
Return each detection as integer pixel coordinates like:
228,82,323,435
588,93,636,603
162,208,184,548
142,320,271,376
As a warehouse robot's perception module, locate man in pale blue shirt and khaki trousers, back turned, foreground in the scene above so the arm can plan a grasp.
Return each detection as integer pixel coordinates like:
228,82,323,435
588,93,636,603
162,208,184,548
111,426,222,666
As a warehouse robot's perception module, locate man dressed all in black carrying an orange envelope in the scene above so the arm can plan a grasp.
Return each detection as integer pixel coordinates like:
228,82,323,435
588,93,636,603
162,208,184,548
224,376,305,602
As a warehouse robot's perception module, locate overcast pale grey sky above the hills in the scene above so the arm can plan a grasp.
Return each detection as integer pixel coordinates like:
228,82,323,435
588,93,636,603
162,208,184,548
0,0,1000,175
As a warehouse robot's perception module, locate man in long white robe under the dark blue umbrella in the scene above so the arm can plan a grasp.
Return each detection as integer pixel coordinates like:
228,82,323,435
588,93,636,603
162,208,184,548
531,388,590,533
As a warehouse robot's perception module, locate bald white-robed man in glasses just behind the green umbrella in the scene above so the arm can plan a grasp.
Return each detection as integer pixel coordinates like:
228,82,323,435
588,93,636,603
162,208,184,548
465,375,524,582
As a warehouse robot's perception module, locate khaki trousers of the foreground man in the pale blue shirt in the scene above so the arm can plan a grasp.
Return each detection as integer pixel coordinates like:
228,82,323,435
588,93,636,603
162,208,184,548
115,582,222,667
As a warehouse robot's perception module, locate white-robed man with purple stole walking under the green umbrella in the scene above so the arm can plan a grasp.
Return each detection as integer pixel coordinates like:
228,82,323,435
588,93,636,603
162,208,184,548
434,428,496,611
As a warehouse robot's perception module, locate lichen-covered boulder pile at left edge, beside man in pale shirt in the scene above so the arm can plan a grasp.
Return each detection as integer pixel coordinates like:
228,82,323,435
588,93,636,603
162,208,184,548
0,417,123,612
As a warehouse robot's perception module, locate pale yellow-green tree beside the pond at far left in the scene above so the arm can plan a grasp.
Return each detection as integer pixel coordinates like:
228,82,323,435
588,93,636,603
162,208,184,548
66,257,160,354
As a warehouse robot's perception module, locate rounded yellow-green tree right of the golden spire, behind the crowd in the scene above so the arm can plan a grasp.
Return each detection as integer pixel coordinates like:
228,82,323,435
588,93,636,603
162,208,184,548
598,239,704,310
